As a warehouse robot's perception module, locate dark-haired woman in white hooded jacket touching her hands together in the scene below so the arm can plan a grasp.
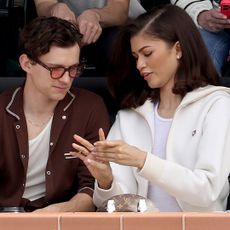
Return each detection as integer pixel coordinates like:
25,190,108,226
66,5,230,211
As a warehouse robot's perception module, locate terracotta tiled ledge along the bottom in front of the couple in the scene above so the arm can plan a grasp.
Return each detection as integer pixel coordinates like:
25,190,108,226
0,213,230,230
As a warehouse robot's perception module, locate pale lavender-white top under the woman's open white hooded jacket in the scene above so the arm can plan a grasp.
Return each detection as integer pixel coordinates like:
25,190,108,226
147,105,181,212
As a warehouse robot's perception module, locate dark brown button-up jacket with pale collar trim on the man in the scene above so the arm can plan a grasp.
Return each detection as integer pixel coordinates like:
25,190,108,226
0,88,109,210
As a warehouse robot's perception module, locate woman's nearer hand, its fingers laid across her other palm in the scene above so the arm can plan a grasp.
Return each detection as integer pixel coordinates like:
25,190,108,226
92,140,147,169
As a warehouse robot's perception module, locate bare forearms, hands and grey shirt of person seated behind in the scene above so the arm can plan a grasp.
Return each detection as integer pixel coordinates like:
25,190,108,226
34,0,144,44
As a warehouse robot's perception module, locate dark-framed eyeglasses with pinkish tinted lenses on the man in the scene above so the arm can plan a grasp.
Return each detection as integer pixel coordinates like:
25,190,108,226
35,59,85,79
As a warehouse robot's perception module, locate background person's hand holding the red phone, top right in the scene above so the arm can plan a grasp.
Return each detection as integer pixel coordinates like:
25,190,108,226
197,9,230,32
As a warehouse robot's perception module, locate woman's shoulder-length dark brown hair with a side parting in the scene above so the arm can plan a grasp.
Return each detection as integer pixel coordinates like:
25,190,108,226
108,5,219,108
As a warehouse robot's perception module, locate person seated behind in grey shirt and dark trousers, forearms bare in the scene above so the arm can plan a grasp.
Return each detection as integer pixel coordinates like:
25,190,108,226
34,0,145,73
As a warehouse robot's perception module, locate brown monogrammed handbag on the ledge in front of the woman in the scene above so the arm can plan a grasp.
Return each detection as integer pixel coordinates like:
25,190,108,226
97,194,159,212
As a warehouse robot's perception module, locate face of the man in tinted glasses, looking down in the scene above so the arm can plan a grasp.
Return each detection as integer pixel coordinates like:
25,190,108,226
26,44,80,101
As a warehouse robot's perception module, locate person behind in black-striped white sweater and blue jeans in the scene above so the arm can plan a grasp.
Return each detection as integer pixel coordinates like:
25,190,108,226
176,0,230,75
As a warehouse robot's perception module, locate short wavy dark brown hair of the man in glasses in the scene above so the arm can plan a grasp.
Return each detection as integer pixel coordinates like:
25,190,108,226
19,17,82,61
